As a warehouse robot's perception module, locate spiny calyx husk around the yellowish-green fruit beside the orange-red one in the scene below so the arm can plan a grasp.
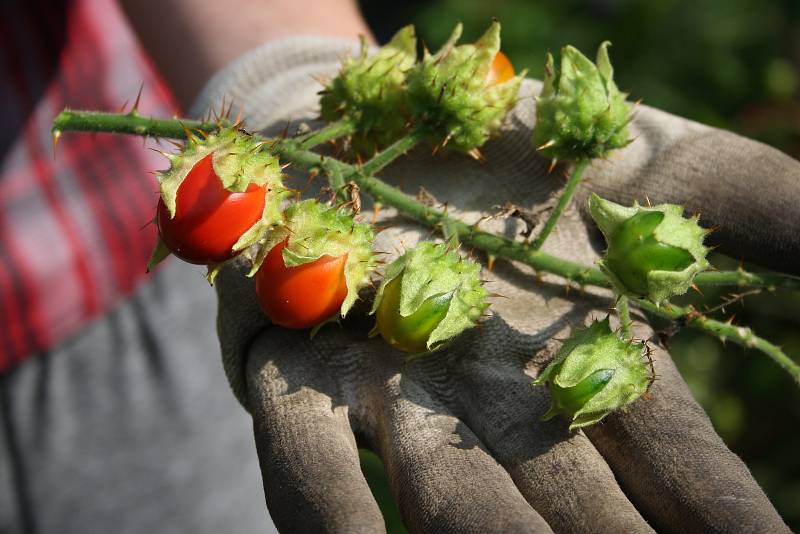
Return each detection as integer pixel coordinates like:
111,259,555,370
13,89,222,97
371,241,489,356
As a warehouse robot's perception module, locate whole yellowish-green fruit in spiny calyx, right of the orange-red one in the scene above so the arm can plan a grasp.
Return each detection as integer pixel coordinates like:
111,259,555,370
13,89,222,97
371,241,489,356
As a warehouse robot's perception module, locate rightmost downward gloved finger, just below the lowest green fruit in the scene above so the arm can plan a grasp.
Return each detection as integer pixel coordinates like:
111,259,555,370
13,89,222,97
586,338,788,533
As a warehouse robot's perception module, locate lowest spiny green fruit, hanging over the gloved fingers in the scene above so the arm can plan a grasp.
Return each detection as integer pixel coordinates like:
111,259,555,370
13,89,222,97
533,318,651,430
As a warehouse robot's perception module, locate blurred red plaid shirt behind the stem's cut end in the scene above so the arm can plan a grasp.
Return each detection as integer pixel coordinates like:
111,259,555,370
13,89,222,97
0,0,175,372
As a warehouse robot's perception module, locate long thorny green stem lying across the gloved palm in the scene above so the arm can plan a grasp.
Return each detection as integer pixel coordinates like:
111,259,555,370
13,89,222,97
53,110,800,384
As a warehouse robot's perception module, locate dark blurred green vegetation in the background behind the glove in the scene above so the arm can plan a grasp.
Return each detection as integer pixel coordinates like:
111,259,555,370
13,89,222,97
361,0,800,531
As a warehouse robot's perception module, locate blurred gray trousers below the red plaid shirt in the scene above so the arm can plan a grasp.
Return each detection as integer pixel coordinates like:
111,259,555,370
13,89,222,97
0,260,274,534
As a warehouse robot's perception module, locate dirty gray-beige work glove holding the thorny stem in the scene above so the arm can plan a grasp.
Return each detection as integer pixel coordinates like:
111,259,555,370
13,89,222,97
191,39,800,533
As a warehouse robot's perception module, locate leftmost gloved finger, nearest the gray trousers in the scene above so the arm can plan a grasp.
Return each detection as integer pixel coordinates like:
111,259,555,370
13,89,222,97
247,335,385,532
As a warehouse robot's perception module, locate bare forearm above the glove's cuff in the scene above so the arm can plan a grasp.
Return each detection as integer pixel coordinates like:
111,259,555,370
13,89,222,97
120,0,371,109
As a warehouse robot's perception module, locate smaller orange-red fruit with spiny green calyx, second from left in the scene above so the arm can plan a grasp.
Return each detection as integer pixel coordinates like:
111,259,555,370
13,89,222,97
253,199,376,328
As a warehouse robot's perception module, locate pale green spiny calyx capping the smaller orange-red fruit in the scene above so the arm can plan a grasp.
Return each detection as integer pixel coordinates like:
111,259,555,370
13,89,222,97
250,199,376,317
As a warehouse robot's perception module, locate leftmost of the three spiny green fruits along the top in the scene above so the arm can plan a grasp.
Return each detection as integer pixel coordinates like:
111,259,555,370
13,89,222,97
320,25,417,156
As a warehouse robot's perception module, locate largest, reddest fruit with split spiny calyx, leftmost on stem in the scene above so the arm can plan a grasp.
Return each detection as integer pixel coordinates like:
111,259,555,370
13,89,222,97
149,128,288,280
